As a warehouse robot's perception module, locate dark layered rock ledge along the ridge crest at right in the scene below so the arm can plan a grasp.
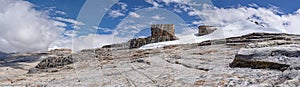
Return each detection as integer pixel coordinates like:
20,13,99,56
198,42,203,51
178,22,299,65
197,33,300,48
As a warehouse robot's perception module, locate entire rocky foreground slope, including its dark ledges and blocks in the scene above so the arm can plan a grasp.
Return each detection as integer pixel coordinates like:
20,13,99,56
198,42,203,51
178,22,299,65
0,33,300,87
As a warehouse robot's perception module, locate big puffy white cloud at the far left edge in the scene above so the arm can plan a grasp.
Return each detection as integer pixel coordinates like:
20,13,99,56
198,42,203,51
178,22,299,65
0,0,66,52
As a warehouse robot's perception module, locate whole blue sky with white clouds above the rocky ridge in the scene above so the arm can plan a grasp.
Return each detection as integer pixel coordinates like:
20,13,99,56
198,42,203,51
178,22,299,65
0,0,300,52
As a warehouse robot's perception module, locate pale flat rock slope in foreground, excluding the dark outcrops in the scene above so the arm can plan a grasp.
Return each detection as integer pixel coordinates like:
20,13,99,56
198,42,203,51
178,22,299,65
0,32,300,87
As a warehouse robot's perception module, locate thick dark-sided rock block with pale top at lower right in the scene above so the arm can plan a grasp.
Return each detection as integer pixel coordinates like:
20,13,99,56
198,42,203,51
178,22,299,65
230,44,300,71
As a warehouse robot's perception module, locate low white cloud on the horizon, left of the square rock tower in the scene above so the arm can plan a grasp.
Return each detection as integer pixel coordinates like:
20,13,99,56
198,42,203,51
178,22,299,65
49,34,126,51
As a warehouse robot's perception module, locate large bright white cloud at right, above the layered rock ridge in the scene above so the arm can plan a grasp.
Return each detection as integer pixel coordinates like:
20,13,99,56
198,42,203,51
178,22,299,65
188,6,300,35
